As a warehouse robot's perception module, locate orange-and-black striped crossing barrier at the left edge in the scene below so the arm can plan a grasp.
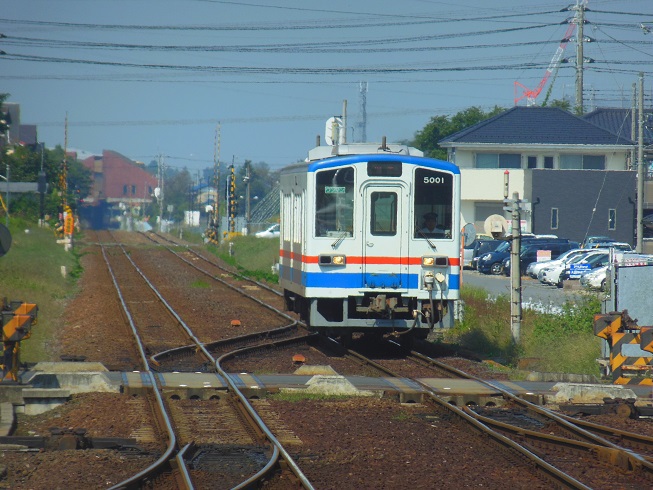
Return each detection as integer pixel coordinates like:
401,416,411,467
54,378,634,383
0,298,39,381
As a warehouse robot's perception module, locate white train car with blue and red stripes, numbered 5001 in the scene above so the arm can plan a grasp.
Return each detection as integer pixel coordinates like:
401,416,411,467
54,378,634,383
279,141,461,338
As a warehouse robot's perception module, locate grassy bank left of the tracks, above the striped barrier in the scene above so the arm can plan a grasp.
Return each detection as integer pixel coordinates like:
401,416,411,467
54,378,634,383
0,217,83,362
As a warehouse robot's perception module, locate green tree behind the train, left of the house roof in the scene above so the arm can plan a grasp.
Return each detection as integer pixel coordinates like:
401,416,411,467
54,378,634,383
409,106,505,160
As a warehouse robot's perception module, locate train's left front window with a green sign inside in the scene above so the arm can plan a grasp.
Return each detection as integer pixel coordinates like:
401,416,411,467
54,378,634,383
315,167,355,238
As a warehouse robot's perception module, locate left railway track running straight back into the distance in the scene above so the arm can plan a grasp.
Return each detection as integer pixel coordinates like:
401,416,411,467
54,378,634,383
71,231,312,488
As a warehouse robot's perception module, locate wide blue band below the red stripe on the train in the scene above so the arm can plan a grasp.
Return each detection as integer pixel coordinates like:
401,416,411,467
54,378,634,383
279,266,460,290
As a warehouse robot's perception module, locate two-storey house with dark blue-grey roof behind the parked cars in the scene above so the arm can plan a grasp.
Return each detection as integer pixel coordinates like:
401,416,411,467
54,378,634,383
439,107,653,244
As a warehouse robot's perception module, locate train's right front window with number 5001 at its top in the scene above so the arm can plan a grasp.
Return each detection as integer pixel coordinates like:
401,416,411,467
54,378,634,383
413,168,453,240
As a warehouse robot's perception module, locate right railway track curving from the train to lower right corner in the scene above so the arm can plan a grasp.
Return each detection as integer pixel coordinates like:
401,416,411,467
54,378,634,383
354,338,653,488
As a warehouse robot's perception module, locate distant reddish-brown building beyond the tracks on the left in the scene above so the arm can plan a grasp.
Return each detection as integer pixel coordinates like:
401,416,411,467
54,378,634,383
80,150,157,229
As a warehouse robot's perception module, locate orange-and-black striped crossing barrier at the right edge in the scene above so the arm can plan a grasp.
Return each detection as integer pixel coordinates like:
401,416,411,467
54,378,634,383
594,310,653,386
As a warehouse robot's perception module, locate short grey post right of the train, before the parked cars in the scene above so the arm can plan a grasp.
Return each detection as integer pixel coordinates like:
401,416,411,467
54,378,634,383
503,171,528,344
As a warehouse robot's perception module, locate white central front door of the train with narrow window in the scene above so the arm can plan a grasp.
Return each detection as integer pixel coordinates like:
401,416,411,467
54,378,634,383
362,185,408,289
